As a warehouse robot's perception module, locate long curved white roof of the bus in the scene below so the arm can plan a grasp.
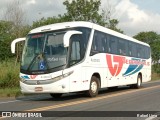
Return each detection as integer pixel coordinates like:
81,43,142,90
29,21,149,46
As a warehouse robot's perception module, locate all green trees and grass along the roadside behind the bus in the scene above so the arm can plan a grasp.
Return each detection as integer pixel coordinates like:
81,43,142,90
0,0,160,97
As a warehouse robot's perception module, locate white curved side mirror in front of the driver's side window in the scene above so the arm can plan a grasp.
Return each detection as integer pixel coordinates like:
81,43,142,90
63,30,82,47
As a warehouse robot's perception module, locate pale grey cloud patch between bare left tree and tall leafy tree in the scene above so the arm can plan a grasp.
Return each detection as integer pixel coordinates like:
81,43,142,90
24,0,66,24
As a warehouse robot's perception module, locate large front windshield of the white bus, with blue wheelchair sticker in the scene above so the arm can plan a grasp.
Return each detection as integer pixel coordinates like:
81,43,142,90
21,31,67,71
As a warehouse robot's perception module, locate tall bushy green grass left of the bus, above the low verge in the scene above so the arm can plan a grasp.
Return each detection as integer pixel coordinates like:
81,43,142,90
0,60,19,88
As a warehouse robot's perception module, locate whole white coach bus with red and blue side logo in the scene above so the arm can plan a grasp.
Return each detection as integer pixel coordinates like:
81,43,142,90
11,21,151,98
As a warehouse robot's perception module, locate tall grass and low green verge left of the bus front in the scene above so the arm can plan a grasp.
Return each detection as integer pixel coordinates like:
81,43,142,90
0,59,20,97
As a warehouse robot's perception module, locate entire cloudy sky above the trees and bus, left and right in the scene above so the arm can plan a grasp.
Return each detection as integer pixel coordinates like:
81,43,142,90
0,0,160,36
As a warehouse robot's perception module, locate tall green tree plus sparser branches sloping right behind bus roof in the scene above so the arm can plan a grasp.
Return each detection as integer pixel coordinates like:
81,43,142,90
63,0,123,33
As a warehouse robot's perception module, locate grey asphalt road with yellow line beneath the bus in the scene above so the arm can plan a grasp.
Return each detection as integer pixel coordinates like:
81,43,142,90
0,81,160,120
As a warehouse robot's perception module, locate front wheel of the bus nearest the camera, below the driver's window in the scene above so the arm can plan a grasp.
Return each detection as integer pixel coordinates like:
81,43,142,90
87,76,100,97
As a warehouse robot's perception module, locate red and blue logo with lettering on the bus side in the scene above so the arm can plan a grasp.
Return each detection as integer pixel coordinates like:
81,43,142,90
106,54,150,76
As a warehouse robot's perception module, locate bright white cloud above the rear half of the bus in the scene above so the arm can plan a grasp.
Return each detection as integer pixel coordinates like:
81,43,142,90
115,0,160,36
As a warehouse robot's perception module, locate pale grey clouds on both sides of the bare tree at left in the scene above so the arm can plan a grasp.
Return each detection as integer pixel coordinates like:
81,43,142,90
0,0,66,24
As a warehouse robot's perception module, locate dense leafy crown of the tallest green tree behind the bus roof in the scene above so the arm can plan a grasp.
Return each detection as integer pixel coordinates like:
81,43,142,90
63,0,103,24
